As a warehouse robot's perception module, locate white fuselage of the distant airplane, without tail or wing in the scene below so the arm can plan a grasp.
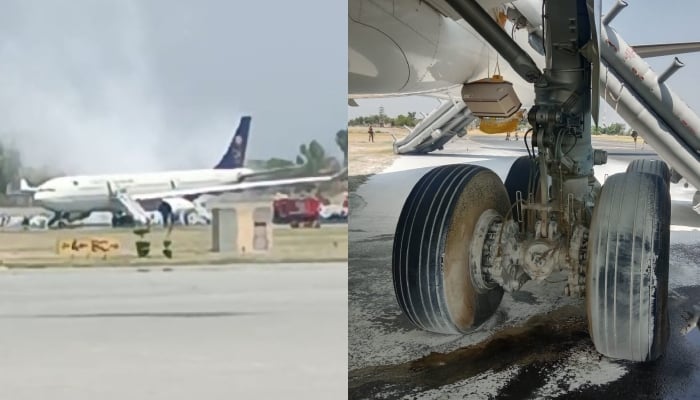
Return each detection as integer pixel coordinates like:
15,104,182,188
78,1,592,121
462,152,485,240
34,168,251,213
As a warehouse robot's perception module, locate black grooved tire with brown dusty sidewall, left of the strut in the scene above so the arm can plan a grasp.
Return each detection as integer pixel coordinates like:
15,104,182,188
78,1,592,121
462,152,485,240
392,164,509,334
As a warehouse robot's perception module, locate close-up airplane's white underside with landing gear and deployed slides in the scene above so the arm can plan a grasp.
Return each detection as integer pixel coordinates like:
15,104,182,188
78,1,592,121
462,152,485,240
348,0,700,362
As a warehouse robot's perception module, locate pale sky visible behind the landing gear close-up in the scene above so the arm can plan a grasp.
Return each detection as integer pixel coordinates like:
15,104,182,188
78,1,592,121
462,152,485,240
347,0,700,125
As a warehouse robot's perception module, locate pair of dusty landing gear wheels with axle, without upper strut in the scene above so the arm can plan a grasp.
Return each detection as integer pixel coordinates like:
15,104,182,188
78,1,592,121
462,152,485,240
392,157,671,361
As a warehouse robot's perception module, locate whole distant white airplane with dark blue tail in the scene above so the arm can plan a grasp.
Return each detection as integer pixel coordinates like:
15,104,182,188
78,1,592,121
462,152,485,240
15,116,343,226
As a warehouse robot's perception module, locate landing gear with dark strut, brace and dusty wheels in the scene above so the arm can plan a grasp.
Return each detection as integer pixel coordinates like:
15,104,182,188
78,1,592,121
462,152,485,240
392,0,671,361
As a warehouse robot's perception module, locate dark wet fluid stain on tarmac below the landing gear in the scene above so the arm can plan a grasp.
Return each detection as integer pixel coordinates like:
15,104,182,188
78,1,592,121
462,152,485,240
348,306,592,398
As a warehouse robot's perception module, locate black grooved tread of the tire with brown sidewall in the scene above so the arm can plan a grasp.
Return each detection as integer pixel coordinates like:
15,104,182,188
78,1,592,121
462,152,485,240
392,165,507,334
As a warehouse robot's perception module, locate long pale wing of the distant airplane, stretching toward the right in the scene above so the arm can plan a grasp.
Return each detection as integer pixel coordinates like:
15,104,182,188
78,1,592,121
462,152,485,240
129,168,347,201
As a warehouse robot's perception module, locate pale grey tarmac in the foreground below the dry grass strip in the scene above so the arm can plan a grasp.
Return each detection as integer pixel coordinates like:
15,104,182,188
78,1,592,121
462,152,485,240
0,263,347,400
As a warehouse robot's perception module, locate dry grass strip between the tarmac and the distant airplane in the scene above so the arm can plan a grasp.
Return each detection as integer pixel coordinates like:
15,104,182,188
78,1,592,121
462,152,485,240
0,225,348,267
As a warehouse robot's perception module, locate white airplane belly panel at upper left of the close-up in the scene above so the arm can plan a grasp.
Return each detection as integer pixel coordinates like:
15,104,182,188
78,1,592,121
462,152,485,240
348,0,541,105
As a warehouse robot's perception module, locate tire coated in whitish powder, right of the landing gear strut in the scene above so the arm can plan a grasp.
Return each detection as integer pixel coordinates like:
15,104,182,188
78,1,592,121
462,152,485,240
586,172,671,361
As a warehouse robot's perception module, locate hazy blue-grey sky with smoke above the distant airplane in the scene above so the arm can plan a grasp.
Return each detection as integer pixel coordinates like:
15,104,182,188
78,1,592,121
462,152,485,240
0,0,347,173
